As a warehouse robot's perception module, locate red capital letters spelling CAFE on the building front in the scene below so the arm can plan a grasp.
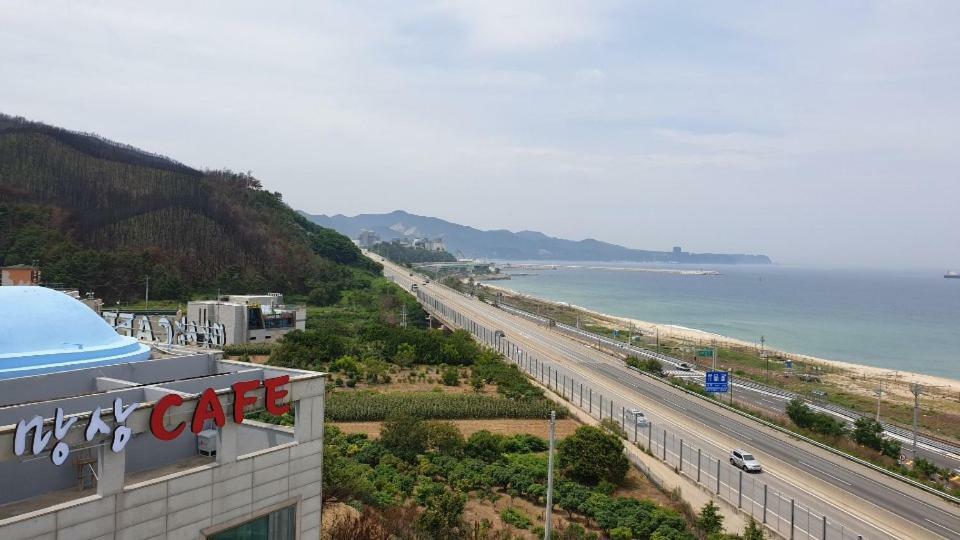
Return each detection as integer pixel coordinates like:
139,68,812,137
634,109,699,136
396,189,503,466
150,375,290,441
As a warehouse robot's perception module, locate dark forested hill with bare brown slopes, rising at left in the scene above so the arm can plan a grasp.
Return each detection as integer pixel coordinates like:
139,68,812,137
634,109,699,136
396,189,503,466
0,114,377,302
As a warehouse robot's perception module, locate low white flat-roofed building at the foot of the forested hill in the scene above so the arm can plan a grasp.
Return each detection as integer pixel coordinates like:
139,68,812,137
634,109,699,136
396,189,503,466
187,293,307,345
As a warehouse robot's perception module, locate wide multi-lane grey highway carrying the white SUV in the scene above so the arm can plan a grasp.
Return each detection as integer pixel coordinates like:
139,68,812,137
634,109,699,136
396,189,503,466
376,255,960,538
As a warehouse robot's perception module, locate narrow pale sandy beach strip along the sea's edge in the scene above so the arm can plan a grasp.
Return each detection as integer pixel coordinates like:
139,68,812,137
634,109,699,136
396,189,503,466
484,283,960,395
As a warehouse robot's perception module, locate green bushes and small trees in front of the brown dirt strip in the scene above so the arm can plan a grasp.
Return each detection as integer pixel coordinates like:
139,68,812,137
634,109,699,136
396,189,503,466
324,422,704,540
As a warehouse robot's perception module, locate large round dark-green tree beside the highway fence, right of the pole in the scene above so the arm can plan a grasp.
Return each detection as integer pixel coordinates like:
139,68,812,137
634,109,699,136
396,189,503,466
557,426,630,485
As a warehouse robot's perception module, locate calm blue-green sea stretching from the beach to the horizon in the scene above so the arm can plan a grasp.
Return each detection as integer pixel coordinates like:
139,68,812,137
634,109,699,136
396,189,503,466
492,261,960,379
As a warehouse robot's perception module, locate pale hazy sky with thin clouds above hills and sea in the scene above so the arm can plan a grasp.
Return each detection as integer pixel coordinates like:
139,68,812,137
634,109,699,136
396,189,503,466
0,0,960,268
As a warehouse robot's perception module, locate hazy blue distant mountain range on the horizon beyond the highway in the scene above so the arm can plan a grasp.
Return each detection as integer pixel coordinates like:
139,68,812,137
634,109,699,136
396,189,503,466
303,210,770,264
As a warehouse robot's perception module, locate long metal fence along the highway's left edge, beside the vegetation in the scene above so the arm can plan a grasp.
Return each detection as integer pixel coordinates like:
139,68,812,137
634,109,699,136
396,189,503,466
417,291,863,540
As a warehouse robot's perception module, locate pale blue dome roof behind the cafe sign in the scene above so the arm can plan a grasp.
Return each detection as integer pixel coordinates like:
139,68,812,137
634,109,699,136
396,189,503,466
0,287,150,379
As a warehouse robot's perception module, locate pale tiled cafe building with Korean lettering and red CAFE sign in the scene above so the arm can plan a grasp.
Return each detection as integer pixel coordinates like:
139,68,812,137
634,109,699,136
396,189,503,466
0,286,325,540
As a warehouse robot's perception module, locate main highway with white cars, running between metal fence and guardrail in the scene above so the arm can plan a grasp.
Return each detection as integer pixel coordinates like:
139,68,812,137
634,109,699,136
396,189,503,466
374,256,960,538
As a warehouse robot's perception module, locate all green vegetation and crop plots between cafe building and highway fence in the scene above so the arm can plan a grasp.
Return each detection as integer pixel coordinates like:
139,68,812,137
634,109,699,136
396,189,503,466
258,270,724,540
